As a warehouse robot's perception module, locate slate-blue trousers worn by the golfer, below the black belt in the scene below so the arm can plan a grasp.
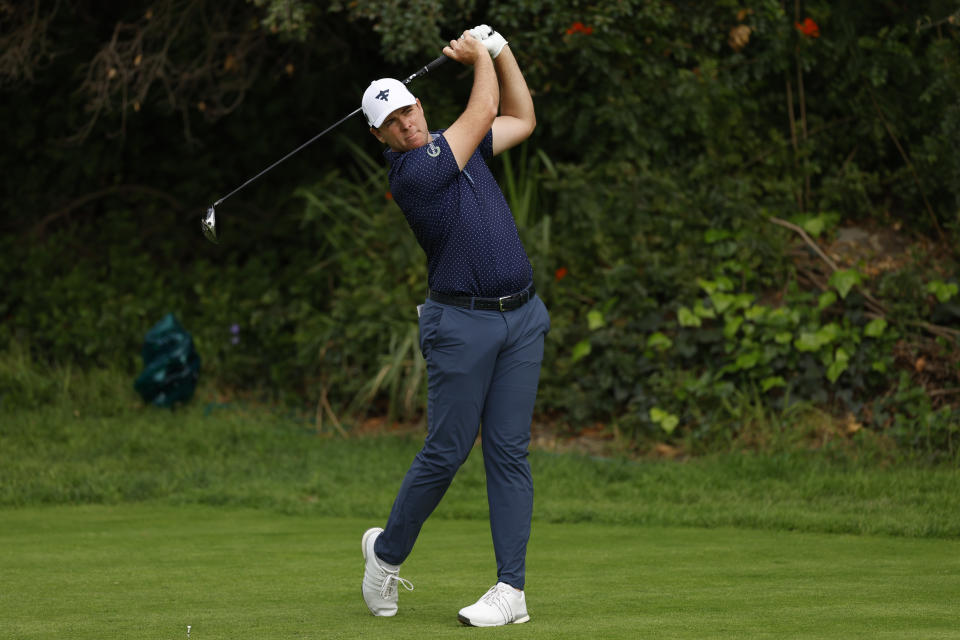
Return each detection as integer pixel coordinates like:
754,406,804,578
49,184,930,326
374,296,550,589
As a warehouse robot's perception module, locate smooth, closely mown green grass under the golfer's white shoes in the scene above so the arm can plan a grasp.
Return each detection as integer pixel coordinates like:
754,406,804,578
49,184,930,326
0,505,960,640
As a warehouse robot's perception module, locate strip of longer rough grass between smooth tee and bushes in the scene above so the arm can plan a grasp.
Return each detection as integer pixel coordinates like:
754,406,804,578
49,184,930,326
0,388,960,537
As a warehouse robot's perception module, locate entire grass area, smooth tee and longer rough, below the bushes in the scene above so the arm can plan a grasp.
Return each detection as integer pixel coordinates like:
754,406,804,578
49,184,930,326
0,361,960,640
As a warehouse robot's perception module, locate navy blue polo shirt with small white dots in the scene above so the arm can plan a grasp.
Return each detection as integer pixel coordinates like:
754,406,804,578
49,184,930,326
384,129,533,298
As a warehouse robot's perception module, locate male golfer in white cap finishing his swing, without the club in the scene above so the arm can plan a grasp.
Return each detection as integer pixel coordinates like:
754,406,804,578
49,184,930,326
362,25,550,627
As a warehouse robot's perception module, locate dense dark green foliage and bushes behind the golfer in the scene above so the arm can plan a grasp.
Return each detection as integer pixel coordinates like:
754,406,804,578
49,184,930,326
0,0,960,460
